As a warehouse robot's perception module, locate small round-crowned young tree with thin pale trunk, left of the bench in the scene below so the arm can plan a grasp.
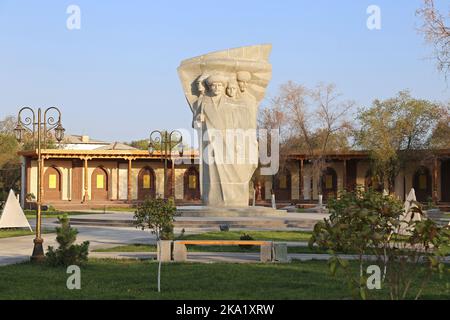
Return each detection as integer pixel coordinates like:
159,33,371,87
134,198,176,292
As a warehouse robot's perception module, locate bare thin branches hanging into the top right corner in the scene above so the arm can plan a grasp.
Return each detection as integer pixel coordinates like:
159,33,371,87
417,0,450,79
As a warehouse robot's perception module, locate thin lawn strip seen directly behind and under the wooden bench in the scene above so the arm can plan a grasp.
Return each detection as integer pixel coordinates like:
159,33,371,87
93,244,326,253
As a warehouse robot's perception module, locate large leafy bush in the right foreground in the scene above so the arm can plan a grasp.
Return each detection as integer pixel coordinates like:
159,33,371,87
309,190,450,300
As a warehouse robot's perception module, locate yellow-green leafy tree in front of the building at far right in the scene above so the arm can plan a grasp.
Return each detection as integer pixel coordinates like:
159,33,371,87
356,91,444,192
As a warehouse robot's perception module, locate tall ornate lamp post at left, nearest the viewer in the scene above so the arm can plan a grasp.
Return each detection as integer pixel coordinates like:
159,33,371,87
14,107,65,261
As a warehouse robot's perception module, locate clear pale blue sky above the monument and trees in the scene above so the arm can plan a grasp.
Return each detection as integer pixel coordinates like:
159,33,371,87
0,0,450,141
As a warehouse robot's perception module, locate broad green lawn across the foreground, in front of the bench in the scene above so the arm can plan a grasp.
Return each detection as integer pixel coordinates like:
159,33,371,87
0,259,450,300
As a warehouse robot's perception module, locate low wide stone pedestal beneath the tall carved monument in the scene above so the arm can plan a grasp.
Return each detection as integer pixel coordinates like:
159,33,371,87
177,206,287,217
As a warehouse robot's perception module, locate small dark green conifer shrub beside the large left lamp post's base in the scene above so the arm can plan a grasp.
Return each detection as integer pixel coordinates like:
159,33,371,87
46,215,89,267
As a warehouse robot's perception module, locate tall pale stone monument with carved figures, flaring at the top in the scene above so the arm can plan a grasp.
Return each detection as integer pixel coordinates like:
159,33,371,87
178,45,272,208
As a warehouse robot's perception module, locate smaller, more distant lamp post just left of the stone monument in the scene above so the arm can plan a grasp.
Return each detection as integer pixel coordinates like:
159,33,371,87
148,130,183,199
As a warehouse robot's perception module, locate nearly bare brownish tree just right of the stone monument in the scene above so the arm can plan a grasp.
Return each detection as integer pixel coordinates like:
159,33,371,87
273,81,354,198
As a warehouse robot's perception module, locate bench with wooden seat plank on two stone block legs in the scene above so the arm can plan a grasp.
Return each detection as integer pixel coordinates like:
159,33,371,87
173,240,272,262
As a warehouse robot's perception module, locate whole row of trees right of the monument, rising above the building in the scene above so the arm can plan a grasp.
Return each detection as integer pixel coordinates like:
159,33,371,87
259,81,450,192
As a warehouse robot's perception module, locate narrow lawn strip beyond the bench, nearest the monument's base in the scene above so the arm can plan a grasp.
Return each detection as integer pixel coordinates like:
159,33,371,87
182,231,311,241
